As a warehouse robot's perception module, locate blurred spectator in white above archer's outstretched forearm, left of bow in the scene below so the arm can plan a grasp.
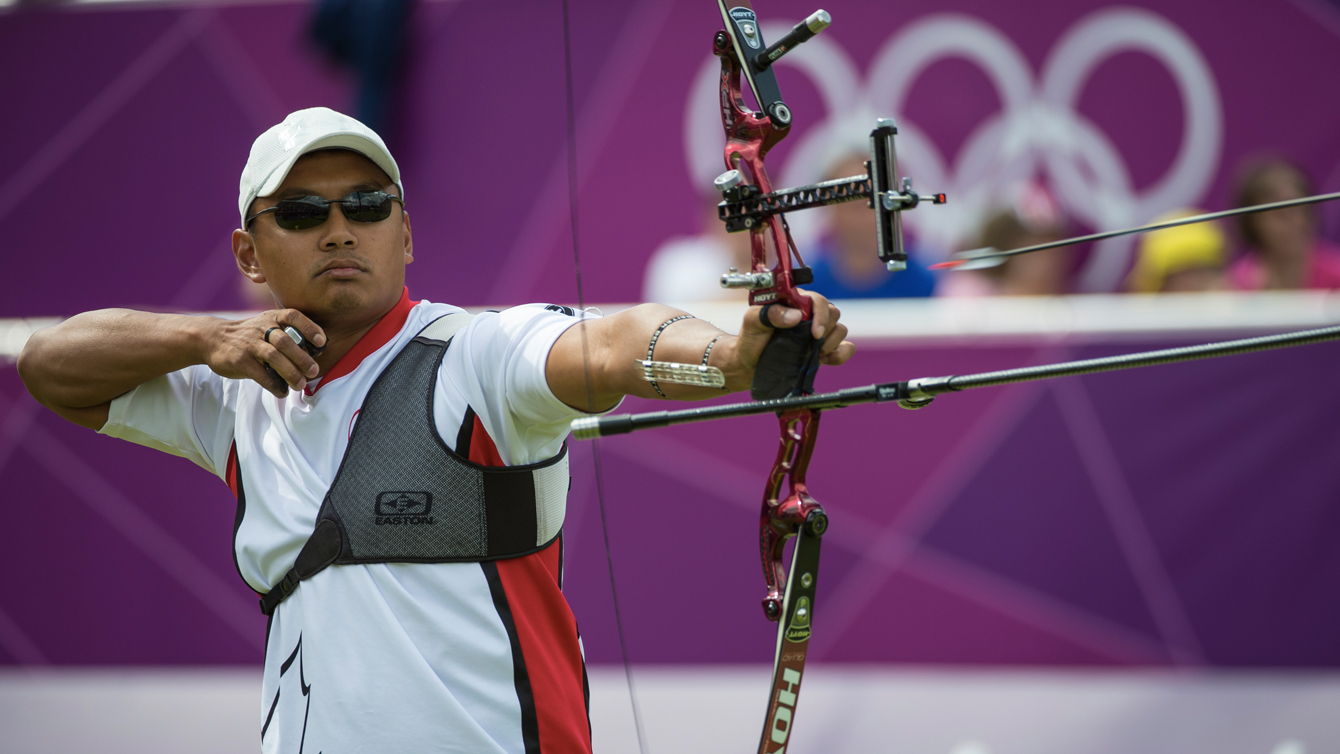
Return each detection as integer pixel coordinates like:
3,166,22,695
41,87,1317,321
642,200,750,304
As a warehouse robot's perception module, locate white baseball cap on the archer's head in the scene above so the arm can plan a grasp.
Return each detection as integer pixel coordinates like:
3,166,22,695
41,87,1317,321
237,107,405,228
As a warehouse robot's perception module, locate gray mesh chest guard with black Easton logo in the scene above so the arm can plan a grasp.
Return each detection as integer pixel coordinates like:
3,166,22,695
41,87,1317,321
260,312,568,615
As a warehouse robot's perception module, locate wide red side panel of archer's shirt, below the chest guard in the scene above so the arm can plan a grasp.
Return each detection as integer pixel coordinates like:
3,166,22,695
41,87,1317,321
497,541,591,754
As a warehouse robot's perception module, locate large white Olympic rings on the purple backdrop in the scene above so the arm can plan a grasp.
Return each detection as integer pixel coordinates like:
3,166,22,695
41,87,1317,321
683,8,1223,291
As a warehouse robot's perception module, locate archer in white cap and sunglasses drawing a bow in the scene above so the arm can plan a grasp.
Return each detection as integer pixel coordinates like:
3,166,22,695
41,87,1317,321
19,108,854,754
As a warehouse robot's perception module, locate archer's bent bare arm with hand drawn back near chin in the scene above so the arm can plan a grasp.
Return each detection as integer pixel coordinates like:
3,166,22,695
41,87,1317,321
19,309,324,430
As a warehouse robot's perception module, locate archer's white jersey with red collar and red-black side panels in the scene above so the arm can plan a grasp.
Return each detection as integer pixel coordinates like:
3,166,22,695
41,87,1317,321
101,292,605,754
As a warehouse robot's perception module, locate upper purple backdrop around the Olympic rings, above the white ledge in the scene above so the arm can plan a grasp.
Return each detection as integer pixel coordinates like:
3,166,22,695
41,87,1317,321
0,0,1340,316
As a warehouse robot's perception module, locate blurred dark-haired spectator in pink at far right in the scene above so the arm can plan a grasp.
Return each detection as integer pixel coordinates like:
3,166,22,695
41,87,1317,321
1229,159,1340,291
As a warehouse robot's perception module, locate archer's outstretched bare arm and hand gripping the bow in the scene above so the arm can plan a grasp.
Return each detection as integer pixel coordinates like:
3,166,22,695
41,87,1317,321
545,292,856,414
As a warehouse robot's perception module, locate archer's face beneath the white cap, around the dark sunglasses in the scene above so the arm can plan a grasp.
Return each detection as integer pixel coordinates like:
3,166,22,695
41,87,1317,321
233,150,414,324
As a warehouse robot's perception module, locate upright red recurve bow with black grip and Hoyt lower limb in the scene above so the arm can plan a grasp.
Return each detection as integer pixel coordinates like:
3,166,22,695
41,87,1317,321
713,0,828,754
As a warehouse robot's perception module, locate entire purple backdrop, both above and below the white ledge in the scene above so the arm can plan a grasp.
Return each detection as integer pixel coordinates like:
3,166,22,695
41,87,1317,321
0,0,1340,666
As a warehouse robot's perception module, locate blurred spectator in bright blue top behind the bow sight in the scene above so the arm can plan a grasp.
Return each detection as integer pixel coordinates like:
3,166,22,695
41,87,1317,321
801,155,935,299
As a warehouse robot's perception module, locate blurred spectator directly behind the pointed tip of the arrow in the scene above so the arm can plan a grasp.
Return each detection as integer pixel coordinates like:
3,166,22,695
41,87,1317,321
939,182,1071,296
